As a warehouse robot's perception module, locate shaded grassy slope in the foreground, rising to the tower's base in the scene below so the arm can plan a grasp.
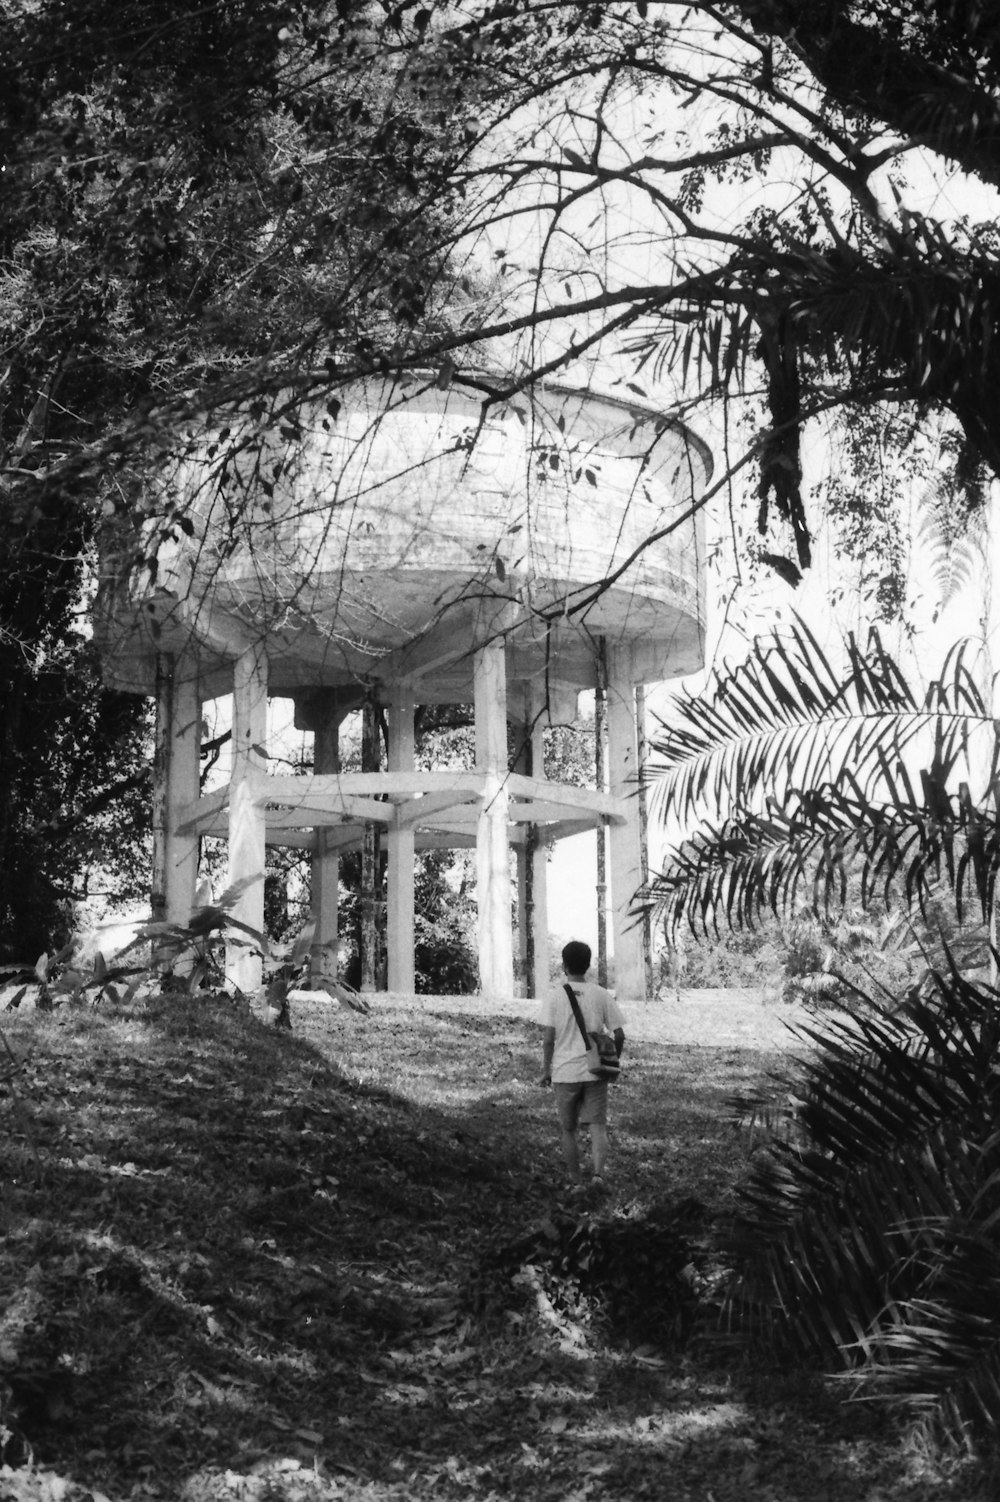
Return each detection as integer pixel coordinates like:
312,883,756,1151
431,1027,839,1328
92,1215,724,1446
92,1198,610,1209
0,999,991,1502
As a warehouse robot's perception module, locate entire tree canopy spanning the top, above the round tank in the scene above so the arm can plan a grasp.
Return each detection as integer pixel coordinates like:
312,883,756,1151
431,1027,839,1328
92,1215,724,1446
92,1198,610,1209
7,0,1000,949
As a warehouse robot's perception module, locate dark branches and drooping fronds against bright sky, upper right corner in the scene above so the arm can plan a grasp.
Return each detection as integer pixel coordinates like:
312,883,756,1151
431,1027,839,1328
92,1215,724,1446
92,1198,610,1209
435,0,1000,577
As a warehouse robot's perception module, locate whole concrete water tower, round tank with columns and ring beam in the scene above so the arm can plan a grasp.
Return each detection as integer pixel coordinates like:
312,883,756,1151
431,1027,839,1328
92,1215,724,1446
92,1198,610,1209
95,374,710,1000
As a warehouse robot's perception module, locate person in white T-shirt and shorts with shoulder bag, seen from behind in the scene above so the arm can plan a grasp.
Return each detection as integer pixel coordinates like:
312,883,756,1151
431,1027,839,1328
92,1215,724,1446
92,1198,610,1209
539,939,625,1184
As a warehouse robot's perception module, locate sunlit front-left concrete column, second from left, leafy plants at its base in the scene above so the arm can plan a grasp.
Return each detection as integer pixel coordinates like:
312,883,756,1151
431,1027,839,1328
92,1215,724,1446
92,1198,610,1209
225,647,267,996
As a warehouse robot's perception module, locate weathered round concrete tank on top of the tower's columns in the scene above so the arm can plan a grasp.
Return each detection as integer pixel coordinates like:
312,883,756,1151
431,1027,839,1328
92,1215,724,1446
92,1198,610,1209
96,374,710,697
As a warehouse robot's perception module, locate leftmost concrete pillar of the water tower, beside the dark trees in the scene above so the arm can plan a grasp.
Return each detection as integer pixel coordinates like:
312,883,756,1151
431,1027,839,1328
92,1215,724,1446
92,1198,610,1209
152,653,201,925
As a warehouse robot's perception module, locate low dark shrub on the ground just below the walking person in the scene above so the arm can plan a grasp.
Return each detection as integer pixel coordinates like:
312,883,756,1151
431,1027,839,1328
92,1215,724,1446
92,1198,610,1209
479,1199,716,1346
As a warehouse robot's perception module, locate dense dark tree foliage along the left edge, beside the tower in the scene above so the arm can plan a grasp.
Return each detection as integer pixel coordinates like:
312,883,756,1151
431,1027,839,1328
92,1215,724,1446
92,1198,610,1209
0,0,477,952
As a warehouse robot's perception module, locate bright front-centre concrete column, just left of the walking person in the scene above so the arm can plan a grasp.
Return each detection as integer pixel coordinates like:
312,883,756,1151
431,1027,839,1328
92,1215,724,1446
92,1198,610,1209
473,640,514,1000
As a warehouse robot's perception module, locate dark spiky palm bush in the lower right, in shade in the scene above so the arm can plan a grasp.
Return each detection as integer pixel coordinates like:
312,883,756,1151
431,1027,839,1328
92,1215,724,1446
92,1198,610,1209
731,967,1000,1433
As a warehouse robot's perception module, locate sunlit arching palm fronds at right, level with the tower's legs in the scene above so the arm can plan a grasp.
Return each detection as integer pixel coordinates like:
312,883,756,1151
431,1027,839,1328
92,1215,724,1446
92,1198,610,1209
649,623,1000,931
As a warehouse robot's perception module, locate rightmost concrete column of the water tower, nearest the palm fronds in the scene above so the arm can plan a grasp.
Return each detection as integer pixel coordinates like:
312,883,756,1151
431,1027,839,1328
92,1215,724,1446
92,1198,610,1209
608,647,646,1006
